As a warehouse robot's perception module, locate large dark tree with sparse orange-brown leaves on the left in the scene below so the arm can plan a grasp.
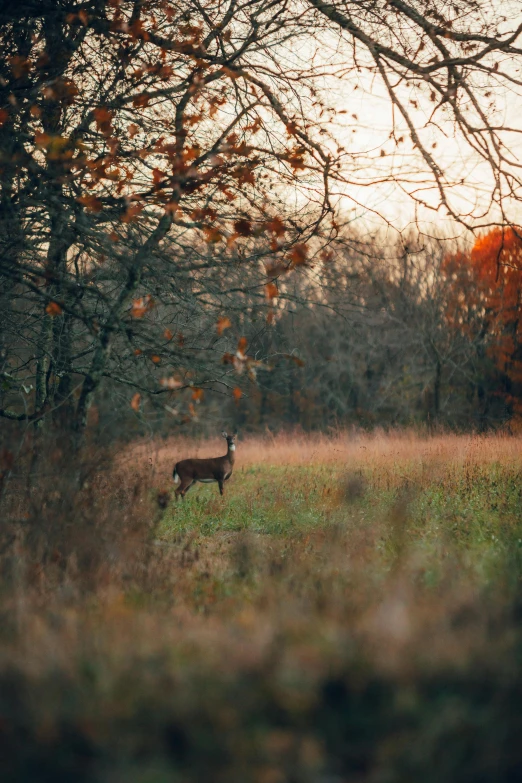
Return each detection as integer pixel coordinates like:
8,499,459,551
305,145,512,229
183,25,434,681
0,2,330,440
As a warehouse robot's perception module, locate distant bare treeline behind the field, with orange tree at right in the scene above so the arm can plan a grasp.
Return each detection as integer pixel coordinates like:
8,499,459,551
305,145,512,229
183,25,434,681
89,229,522,434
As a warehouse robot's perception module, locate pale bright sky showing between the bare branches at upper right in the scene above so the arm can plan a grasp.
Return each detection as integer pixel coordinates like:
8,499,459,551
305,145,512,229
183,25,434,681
282,0,522,233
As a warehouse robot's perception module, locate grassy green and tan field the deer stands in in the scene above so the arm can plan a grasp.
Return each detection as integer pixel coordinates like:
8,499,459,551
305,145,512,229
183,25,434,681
0,434,522,783
